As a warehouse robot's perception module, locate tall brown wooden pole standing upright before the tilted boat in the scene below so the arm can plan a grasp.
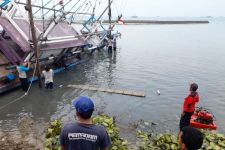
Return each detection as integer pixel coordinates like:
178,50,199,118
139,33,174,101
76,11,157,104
25,0,42,88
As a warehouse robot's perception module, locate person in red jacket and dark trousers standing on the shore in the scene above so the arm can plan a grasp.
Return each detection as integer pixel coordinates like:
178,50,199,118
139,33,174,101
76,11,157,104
180,83,199,131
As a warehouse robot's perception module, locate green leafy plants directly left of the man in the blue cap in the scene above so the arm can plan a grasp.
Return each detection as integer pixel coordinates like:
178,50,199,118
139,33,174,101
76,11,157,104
44,120,62,150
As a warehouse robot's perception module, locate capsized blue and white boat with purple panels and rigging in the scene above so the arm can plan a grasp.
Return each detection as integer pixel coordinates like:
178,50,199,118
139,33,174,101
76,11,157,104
0,0,122,93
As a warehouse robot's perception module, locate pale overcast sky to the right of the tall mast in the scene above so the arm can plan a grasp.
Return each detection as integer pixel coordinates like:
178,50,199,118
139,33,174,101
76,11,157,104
108,0,225,17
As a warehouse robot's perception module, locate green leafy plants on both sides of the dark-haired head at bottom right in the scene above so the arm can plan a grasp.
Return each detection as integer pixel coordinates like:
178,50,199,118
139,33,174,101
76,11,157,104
137,130,225,150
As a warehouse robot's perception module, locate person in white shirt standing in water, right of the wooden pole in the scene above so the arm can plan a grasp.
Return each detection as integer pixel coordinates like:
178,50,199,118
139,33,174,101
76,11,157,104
42,66,54,89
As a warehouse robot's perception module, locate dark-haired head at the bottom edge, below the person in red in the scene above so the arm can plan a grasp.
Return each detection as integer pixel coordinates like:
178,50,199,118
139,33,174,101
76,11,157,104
179,126,203,150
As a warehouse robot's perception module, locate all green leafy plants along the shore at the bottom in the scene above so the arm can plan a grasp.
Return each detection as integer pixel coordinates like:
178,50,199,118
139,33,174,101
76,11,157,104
44,115,225,150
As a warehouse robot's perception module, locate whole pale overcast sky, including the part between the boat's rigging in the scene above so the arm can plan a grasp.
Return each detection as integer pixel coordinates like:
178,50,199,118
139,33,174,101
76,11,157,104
0,0,225,17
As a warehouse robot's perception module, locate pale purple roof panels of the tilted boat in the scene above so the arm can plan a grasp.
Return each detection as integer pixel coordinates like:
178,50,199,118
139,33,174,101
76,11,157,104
0,17,85,52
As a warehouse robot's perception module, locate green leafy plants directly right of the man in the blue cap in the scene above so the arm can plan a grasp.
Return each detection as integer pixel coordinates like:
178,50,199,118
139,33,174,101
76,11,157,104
92,115,128,150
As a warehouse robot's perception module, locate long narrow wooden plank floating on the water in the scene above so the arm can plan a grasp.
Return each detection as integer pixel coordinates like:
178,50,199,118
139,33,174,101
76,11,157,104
67,85,146,97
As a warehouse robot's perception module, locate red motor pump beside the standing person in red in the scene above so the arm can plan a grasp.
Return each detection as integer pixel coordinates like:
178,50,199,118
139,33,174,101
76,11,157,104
190,107,217,130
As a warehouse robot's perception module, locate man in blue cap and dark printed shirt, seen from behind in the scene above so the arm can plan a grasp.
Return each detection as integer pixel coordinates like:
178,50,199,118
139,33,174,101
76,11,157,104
60,96,110,150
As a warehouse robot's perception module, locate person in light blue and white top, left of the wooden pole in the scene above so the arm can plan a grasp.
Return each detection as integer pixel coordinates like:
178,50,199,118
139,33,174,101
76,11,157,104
16,62,30,91
